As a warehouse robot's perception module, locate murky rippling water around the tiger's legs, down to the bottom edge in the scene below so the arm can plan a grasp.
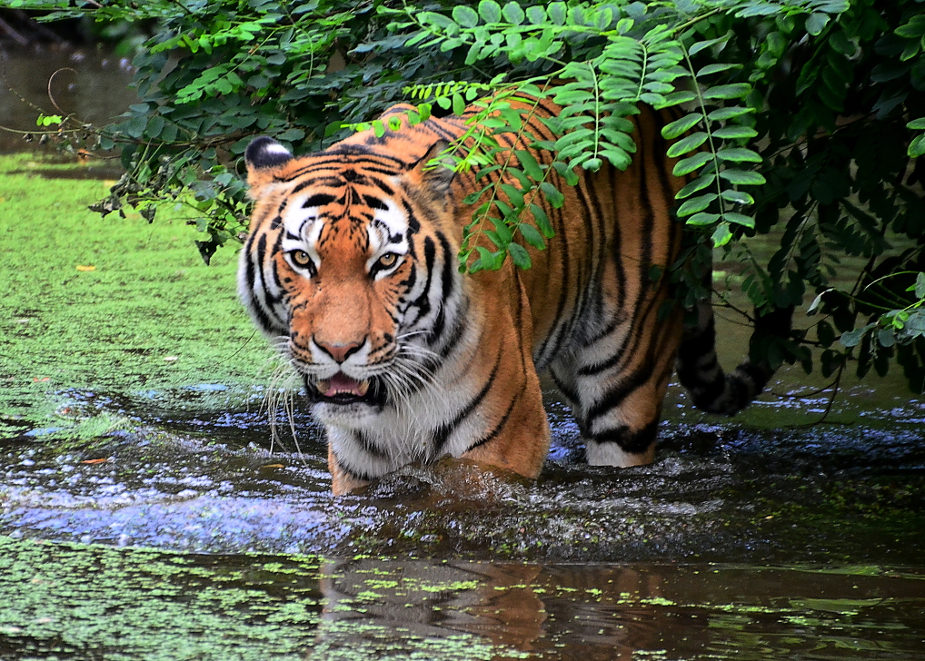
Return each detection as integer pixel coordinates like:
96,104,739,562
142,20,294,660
0,47,925,661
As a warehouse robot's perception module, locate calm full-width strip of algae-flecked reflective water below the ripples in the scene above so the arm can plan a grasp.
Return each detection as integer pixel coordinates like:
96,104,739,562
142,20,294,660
0,537,925,661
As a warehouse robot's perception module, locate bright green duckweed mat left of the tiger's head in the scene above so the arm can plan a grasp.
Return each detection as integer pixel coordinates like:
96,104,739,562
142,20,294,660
0,155,270,433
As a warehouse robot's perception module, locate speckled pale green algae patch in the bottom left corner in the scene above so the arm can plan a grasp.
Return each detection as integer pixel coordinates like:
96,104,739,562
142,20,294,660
0,537,321,660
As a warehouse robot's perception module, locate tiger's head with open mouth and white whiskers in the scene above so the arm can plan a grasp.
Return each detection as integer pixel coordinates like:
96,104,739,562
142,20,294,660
238,138,460,425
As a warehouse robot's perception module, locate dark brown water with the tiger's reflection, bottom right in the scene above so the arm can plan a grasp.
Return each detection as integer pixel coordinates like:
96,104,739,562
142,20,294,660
311,559,925,661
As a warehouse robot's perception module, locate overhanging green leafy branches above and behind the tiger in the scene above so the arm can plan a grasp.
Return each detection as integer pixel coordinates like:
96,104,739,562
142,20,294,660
12,0,925,392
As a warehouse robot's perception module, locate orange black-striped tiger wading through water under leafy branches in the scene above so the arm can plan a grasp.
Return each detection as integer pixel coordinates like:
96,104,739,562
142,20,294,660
238,98,788,495
